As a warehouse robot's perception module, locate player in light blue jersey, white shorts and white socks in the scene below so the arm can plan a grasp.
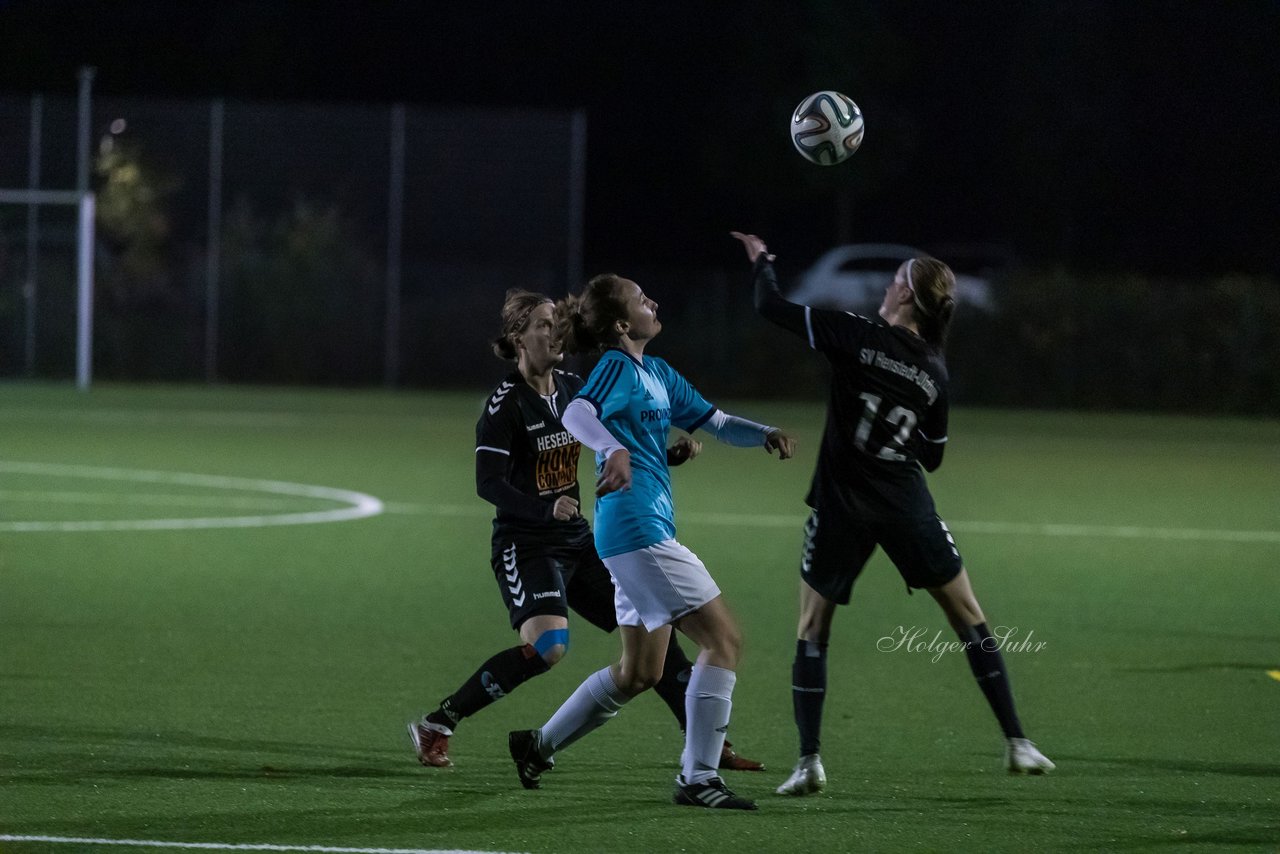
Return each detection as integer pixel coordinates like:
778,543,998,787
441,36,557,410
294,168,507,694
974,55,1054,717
509,274,795,809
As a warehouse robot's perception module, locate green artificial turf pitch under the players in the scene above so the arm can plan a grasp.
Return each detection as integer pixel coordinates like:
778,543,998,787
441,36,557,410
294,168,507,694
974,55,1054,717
0,384,1280,854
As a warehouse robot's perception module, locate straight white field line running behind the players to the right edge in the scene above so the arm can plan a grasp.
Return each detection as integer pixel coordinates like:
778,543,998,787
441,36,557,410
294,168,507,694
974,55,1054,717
384,502,1280,543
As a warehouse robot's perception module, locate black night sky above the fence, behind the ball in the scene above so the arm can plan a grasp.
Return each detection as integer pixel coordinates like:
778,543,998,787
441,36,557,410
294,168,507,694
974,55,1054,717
0,0,1280,273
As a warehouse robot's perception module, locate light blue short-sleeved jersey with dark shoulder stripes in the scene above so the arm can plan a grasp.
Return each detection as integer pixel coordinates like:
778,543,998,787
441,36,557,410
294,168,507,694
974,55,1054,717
577,350,716,557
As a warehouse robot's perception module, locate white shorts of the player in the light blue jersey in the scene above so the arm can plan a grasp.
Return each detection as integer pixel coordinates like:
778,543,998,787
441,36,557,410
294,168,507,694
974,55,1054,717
603,540,719,631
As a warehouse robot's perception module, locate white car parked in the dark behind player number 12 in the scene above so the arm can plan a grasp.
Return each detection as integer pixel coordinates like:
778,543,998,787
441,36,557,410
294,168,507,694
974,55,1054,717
787,243,996,314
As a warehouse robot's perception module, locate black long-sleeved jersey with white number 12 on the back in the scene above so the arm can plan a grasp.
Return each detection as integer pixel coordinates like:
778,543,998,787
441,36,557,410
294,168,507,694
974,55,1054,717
755,256,947,517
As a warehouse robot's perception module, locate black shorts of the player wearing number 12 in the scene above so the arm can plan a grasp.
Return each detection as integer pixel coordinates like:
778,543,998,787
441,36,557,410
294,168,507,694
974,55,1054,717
800,508,964,604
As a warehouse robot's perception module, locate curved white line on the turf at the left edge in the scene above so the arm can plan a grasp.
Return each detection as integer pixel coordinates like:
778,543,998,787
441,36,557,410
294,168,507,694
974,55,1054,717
0,461,383,533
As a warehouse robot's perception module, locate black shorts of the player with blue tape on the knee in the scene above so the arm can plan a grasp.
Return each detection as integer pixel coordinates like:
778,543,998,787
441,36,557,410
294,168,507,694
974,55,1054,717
492,536,618,631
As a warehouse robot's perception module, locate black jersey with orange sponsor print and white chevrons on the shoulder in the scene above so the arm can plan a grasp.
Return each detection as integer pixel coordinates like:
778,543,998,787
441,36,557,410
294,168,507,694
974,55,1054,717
476,370,591,544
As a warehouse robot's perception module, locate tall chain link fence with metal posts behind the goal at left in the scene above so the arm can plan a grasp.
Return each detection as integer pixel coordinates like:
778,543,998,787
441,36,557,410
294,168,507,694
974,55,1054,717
0,96,585,385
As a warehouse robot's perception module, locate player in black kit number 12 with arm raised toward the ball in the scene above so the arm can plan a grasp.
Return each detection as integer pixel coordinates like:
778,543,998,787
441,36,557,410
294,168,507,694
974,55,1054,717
732,232,1053,795
